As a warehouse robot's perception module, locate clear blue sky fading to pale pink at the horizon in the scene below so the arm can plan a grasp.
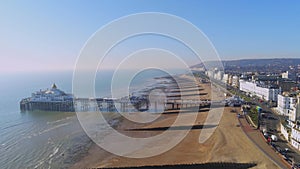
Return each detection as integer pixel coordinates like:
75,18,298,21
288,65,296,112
0,0,300,73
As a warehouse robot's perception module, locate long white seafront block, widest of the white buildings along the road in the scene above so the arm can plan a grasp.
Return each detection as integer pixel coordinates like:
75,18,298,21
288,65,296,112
239,80,281,101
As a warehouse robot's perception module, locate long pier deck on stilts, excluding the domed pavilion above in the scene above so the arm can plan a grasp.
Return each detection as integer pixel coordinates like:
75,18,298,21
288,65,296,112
20,95,225,112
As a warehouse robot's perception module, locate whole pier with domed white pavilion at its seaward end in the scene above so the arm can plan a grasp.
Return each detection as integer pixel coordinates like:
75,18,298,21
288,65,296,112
20,83,239,113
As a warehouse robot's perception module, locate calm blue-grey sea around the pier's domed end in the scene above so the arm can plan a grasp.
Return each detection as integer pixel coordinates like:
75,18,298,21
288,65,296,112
0,70,183,169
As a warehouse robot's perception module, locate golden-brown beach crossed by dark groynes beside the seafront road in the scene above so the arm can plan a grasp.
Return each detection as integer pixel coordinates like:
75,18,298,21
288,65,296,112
72,77,278,168
